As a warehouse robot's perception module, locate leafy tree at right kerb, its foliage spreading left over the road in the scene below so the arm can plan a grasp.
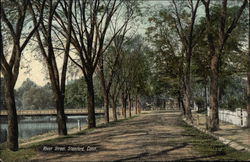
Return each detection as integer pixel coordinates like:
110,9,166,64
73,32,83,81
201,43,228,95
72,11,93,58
147,0,204,120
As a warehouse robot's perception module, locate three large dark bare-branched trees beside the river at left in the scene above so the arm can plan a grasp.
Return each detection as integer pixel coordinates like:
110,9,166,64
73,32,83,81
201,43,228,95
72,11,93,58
0,0,143,151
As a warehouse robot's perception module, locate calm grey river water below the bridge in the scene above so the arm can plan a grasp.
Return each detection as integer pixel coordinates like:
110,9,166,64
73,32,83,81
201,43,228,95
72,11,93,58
0,116,101,143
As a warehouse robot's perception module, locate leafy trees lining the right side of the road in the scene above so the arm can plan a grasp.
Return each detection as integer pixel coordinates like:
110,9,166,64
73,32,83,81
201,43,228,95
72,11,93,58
146,0,250,131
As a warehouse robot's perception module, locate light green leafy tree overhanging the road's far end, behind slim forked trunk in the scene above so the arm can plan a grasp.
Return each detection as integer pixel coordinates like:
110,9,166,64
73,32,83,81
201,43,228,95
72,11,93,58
146,8,186,114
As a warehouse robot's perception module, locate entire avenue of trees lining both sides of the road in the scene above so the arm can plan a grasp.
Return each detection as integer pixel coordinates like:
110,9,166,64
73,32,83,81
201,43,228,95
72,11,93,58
0,0,250,151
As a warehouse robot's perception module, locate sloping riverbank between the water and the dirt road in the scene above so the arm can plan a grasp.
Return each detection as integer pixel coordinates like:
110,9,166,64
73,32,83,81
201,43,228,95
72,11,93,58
0,109,138,162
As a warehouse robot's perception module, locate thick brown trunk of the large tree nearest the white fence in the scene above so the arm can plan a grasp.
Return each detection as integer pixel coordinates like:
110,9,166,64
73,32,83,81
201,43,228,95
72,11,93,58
208,54,219,131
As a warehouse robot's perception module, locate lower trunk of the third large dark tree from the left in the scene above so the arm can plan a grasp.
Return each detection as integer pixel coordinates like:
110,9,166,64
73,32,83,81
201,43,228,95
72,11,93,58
85,75,96,128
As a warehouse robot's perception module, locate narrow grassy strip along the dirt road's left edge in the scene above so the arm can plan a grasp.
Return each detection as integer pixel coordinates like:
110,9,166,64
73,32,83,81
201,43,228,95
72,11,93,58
0,115,138,162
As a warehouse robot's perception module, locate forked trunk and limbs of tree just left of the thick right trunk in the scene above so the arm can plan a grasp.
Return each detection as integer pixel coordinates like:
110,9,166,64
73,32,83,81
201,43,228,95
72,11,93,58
168,0,200,120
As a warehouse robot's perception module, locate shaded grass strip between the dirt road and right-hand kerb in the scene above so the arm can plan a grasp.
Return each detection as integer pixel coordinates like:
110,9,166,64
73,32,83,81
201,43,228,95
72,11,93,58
183,122,250,161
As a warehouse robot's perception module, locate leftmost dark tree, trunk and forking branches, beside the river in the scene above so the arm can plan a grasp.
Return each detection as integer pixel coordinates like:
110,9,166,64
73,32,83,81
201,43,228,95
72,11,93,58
0,0,45,151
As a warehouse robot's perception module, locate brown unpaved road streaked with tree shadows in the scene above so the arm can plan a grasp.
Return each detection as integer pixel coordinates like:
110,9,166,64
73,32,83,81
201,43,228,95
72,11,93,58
33,112,199,161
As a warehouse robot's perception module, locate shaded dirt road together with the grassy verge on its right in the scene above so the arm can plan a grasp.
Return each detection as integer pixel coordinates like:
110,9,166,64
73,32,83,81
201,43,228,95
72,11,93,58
29,112,250,161
